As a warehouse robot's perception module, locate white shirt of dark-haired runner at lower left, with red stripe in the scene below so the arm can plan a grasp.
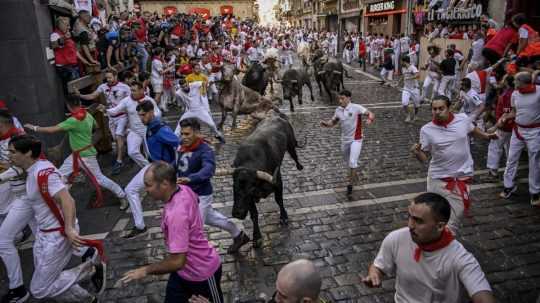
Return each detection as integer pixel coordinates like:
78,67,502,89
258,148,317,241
26,160,66,229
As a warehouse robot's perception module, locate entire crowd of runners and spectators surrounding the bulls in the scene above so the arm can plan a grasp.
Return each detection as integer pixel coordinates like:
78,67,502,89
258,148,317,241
0,3,540,303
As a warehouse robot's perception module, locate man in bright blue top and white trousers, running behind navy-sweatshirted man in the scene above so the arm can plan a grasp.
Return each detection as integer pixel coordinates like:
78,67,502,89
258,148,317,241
124,100,180,239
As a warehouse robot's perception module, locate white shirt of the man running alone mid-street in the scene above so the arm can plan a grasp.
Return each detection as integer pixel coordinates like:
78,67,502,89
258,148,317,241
332,102,368,144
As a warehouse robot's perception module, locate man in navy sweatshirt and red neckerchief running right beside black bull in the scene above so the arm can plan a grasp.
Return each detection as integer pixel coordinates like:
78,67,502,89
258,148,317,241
176,118,249,253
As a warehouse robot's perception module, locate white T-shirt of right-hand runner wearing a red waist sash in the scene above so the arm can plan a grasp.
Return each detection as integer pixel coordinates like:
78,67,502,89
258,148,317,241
420,114,474,179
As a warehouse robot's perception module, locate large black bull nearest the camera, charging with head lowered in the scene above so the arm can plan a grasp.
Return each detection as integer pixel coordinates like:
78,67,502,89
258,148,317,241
217,113,304,247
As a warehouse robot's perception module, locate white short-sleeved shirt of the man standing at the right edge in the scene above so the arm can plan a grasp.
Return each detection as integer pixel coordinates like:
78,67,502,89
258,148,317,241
511,85,540,125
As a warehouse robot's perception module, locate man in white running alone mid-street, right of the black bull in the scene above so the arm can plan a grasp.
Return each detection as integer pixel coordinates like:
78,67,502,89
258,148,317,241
320,90,375,200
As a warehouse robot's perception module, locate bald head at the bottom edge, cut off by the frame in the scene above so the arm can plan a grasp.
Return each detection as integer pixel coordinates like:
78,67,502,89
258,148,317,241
276,259,322,302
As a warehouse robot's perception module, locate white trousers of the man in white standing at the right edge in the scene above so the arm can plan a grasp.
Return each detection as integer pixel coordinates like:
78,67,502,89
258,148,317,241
504,127,540,195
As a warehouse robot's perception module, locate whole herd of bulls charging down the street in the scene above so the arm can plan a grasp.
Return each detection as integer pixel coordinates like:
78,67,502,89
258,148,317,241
216,52,350,247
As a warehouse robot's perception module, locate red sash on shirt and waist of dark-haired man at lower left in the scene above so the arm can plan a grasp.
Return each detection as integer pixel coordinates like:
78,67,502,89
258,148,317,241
37,167,106,261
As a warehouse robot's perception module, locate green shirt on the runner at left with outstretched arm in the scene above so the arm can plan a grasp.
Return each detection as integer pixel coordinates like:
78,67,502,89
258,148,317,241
58,113,97,157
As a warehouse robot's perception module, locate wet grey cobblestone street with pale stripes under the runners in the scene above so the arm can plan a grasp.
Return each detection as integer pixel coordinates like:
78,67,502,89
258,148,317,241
0,67,540,303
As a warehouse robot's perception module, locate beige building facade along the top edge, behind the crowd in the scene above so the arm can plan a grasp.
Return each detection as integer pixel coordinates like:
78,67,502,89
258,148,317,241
136,0,259,20
